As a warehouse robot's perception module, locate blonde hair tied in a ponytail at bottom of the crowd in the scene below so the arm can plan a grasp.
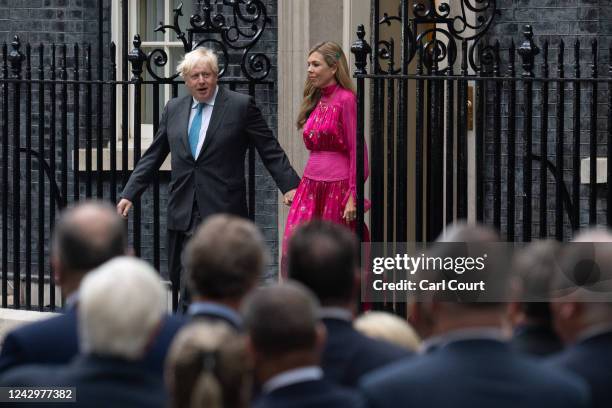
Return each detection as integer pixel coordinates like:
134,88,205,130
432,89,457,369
165,321,252,408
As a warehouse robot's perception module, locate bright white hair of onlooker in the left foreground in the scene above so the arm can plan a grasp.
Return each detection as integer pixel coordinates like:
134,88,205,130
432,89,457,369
77,256,166,360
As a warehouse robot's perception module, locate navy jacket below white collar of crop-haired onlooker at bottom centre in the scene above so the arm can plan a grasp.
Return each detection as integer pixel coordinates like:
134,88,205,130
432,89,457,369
253,380,365,408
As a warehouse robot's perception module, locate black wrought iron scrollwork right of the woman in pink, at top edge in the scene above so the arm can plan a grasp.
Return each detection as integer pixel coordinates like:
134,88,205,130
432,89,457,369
373,0,499,74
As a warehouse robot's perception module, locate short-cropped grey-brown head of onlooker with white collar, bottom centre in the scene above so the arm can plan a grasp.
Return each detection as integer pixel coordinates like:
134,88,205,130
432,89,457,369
241,281,320,358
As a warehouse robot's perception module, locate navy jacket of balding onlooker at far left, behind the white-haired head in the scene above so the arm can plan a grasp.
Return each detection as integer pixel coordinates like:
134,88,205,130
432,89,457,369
0,308,183,376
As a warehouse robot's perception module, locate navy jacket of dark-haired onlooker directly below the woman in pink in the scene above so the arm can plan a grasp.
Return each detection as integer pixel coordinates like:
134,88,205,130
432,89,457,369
321,318,411,387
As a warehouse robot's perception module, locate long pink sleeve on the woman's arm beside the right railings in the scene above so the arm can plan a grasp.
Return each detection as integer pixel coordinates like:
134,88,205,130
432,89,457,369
342,92,370,209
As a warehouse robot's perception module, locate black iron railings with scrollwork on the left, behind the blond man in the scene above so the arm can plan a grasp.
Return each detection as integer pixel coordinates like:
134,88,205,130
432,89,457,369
0,0,274,310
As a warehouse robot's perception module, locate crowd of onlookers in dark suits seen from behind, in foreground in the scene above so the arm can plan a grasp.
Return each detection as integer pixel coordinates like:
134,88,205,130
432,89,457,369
0,202,612,408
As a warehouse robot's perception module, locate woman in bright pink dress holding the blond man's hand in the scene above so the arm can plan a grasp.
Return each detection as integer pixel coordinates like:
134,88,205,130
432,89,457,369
281,41,369,277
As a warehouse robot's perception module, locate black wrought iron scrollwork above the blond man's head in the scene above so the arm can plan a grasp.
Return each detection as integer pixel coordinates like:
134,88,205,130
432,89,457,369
132,0,271,82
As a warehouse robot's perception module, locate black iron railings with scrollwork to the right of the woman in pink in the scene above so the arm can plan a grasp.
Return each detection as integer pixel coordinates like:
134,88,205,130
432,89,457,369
352,0,612,249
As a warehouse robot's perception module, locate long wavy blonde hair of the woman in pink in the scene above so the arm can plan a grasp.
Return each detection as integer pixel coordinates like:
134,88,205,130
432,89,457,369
296,41,355,129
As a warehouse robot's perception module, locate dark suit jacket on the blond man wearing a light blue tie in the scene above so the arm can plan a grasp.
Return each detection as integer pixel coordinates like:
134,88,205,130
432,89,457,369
121,87,299,231
